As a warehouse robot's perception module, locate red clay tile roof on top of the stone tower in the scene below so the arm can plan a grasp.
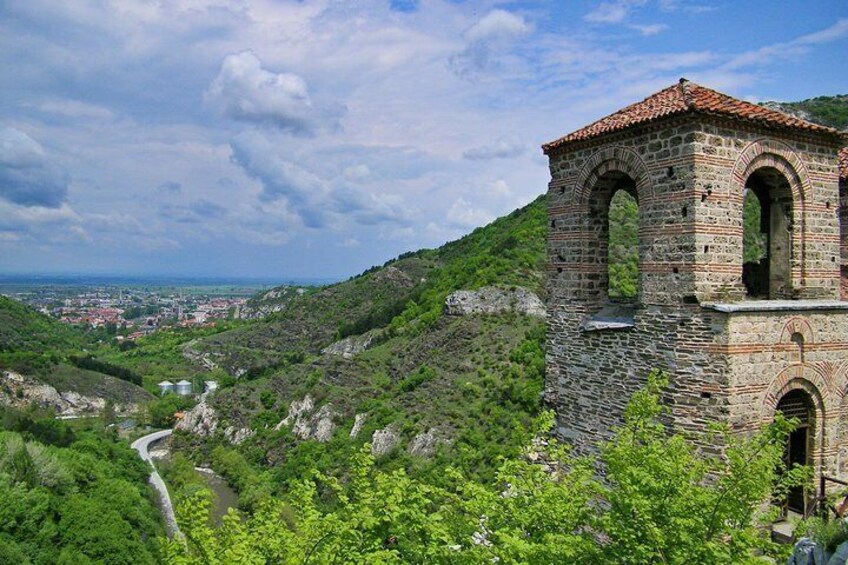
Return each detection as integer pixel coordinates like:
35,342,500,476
542,78,840,154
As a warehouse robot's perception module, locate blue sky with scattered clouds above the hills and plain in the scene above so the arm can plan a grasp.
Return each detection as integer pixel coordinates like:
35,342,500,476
0,0,848,280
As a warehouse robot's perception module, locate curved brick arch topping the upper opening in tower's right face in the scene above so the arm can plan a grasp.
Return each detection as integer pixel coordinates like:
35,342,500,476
732,139,812,202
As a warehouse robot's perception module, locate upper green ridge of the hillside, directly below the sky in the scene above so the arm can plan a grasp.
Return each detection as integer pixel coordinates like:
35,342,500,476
191,197,546,376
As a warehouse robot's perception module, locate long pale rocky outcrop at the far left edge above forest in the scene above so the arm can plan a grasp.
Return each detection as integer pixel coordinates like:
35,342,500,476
0,371,140,418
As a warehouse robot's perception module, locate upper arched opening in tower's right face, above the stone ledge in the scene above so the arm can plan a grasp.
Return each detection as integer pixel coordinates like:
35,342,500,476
742,167,794,299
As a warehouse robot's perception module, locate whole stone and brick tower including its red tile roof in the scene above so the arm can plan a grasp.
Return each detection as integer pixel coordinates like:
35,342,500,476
543,79,848,506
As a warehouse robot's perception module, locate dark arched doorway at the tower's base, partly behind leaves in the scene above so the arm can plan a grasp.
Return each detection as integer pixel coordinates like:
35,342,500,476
777,389,815,514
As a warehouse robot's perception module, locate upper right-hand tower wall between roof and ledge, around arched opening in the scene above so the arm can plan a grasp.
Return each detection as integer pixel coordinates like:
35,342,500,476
689,122,840,301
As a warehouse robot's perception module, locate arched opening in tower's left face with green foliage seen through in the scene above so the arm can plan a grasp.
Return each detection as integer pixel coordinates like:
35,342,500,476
589,171,639,306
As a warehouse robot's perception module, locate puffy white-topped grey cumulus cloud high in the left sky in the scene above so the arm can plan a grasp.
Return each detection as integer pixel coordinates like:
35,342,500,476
203,50,340,134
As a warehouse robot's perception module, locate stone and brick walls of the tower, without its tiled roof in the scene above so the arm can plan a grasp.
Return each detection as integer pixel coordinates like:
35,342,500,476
545,116,848,462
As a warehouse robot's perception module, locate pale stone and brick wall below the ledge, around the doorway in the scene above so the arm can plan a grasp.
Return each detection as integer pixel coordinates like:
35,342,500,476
712,310,848,482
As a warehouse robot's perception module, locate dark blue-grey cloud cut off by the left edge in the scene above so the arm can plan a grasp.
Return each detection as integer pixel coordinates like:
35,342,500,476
0,128,70,208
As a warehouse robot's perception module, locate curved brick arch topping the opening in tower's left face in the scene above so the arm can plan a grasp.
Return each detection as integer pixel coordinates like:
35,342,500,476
575,147,653,205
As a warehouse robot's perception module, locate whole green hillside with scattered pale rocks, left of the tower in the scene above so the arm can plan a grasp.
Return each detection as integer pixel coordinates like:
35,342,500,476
169,197,546,484
